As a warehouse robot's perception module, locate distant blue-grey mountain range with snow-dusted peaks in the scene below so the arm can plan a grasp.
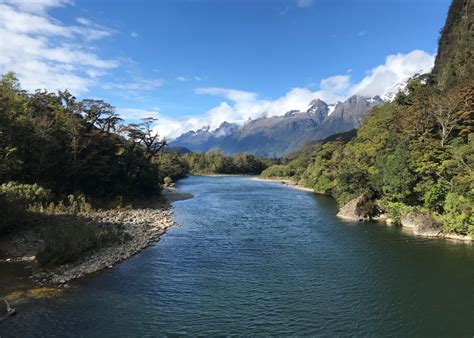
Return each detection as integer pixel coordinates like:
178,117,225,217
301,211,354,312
170,96,383,157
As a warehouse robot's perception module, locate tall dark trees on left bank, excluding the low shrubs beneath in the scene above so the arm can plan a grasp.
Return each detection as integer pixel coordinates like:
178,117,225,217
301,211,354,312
0,73,164,197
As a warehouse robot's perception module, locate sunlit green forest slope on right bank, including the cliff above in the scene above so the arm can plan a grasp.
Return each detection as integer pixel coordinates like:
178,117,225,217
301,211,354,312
262,0,474,235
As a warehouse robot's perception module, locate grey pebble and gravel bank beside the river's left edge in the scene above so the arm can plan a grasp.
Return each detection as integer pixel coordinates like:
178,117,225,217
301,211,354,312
0,188,193,286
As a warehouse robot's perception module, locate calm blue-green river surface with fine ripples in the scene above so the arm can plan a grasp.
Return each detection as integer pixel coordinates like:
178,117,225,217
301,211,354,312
0,177,474,337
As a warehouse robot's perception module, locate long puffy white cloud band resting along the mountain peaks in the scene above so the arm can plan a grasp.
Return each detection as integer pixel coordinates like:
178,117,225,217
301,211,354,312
148,50,434,138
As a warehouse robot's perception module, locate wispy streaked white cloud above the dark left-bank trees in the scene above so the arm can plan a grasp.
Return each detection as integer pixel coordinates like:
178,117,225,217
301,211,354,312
0,0,119,95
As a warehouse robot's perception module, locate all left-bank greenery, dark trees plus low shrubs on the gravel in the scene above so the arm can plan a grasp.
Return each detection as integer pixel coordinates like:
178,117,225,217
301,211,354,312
0,73,169,265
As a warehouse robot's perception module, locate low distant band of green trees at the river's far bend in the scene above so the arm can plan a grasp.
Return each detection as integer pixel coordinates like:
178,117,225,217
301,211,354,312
156,151,275,181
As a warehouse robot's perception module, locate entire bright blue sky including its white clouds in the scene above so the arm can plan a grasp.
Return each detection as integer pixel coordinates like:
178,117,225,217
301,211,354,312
0,0,450,137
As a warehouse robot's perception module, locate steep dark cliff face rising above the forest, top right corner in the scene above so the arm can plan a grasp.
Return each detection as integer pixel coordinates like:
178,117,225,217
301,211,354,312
432,0,474,88
